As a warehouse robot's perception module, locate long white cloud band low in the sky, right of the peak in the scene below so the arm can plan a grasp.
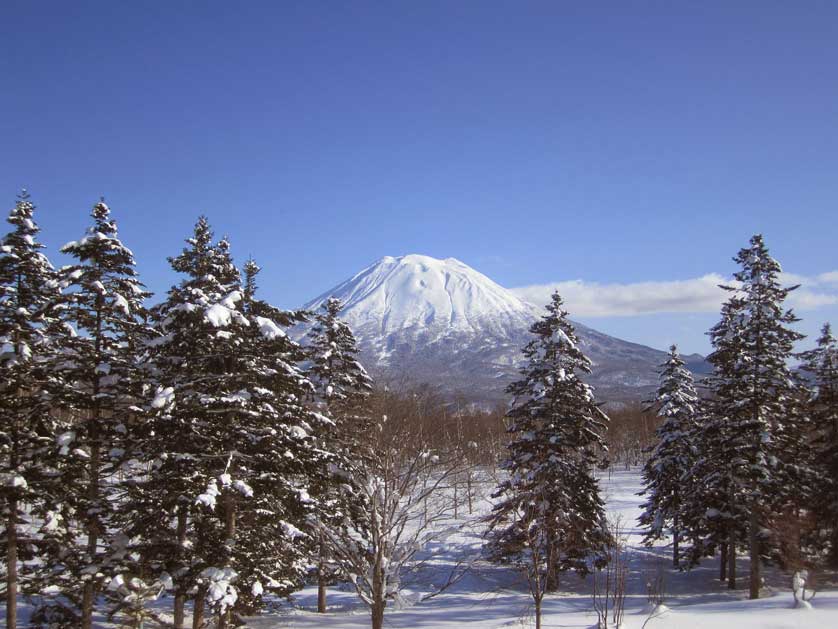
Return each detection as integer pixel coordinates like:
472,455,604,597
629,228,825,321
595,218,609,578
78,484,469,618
512,271,838,317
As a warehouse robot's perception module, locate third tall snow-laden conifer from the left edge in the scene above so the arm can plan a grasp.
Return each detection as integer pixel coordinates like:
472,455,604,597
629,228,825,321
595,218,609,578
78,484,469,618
121,217,230,629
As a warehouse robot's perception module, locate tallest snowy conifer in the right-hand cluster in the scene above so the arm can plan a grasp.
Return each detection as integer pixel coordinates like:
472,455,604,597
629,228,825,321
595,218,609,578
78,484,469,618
708,235,806,598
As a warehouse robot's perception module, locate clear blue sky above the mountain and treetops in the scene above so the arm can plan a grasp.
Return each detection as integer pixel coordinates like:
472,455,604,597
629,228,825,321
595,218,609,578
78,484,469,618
0,0,838,350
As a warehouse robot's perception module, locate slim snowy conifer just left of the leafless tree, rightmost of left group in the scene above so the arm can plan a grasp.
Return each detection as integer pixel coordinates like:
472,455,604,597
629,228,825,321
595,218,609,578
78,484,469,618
307,298,372,613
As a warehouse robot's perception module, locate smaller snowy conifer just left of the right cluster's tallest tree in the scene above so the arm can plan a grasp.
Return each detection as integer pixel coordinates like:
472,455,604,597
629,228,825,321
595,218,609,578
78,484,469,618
639,345,699,567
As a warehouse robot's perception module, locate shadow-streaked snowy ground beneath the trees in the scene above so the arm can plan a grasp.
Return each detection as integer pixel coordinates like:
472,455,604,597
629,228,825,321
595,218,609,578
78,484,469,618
249,470,838,629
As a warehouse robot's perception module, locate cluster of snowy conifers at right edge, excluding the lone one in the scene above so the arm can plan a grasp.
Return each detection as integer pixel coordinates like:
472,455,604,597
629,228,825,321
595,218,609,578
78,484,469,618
640,235,838,598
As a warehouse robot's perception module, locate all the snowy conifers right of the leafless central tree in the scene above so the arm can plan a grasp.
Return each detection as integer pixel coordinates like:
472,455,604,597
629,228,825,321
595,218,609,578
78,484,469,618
472,235,838,629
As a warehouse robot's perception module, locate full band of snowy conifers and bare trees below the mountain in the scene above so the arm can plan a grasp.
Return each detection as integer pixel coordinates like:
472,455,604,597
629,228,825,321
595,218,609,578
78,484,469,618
0,193,838,629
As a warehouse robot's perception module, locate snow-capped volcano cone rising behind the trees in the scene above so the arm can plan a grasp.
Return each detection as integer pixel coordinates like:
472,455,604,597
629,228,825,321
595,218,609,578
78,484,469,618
299,255,704,402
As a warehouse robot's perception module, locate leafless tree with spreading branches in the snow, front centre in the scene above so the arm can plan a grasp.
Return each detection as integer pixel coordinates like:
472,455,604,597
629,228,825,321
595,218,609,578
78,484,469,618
322,416,468,629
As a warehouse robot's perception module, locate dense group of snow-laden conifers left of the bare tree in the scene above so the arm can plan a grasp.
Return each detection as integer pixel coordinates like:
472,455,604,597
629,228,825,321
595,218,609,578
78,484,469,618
0,193,398,628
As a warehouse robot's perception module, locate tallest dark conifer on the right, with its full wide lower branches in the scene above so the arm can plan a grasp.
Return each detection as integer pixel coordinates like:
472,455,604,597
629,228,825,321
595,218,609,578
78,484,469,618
685,235,811,598
